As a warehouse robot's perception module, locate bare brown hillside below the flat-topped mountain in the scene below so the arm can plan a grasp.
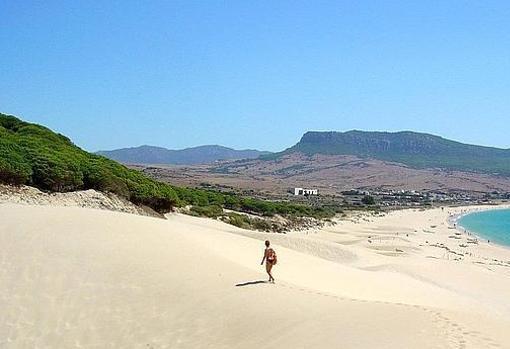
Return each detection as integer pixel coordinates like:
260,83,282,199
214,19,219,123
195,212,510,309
130,153,510,194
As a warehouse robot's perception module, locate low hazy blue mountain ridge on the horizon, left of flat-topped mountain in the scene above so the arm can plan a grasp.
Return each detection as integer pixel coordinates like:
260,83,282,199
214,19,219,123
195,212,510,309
97,145,270,165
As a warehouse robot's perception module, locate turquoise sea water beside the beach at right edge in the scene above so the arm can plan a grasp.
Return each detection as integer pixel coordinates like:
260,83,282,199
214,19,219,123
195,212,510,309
458,210,510,246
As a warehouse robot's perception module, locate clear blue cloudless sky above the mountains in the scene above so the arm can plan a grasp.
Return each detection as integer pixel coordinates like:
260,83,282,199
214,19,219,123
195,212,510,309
0,0,510,151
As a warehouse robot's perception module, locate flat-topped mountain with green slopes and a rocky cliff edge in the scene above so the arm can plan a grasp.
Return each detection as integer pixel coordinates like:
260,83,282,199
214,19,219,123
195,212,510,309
273,131,510,176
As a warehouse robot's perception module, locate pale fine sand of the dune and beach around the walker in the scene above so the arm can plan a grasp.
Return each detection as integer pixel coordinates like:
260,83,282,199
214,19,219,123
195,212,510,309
0,204,510,348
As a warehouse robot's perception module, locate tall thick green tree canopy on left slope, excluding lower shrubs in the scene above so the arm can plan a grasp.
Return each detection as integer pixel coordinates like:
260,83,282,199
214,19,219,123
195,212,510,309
0,114,179,212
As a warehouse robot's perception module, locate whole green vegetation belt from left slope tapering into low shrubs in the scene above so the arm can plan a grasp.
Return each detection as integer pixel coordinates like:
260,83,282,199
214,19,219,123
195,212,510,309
0,114,334,218
